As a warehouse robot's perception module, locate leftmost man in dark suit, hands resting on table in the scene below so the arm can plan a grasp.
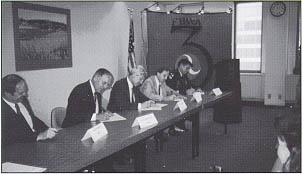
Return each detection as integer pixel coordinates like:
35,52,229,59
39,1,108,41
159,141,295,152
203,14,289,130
1,74,57,146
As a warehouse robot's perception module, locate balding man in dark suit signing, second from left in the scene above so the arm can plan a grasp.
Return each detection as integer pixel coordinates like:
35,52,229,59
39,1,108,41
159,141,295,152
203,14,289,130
62,68,114,127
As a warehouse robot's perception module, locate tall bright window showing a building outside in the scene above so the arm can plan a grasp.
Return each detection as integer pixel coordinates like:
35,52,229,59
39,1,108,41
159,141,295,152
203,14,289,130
235,2,262,72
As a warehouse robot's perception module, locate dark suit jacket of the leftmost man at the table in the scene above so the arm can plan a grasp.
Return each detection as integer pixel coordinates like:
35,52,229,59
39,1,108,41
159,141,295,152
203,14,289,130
1,99,48,146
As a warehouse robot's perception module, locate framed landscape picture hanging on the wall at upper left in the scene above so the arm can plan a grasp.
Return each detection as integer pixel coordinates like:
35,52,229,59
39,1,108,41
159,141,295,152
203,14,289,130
12,2,72,71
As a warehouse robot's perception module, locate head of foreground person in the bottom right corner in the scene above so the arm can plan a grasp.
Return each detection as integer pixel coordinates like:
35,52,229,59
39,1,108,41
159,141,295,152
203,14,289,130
272,116,301,172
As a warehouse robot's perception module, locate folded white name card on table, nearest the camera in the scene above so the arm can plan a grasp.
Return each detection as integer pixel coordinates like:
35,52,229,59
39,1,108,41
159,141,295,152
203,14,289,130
81,122,108,142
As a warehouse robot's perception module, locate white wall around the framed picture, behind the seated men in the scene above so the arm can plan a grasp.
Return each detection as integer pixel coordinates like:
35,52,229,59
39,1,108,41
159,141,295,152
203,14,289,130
2,2,149,125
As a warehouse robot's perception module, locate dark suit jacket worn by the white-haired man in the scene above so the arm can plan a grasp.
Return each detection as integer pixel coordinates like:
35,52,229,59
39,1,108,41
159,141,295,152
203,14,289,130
107,78,148,112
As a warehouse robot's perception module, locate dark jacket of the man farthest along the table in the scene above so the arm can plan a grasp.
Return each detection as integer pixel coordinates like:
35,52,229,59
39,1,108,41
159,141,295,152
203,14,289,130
166,69,195,95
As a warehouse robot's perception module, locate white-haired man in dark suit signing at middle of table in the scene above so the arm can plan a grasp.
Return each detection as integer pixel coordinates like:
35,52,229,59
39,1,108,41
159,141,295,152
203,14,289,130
107,65,154,112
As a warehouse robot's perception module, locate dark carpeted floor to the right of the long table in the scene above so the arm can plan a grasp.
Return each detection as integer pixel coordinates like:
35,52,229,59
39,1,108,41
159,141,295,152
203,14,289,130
115,106,301,173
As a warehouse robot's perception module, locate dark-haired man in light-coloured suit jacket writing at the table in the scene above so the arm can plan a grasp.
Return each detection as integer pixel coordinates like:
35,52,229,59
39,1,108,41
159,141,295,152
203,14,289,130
140,68,185,136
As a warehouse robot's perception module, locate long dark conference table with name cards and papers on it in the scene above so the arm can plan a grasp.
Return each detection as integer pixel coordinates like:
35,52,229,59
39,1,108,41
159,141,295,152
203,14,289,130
1,92,232,172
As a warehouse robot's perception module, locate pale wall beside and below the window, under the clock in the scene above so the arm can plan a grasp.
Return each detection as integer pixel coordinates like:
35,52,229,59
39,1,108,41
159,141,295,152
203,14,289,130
240,2,300,105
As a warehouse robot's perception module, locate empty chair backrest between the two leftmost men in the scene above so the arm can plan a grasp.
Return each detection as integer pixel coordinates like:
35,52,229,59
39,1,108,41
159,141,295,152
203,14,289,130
51,107,66,128
